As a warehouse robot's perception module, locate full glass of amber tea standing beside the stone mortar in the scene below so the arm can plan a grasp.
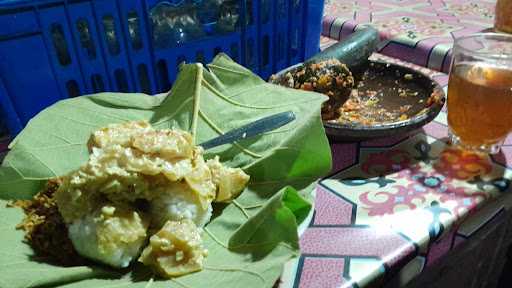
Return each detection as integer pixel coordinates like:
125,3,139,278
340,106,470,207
448,33,512,154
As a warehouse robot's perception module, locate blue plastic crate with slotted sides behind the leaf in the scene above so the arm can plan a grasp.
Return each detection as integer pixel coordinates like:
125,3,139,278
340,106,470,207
0,0,324,135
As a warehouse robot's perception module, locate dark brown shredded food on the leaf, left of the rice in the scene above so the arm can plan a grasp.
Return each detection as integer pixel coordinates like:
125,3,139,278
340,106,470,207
12,180,85,266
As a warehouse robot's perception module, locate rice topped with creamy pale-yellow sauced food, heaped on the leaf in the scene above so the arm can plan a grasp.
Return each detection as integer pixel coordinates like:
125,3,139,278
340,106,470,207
34,122,249,276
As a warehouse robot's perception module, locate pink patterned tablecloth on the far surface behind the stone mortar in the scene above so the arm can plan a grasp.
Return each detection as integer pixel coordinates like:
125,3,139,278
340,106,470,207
322,0,495,72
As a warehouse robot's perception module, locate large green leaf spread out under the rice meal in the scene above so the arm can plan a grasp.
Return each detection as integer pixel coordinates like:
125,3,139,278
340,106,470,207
0,55,331,288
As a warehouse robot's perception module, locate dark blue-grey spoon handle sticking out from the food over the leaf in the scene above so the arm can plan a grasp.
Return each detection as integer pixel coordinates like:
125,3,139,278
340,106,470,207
199,111,295,150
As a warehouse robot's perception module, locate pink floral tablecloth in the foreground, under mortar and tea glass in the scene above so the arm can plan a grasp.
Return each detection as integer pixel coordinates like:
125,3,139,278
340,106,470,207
281,52,512,288
